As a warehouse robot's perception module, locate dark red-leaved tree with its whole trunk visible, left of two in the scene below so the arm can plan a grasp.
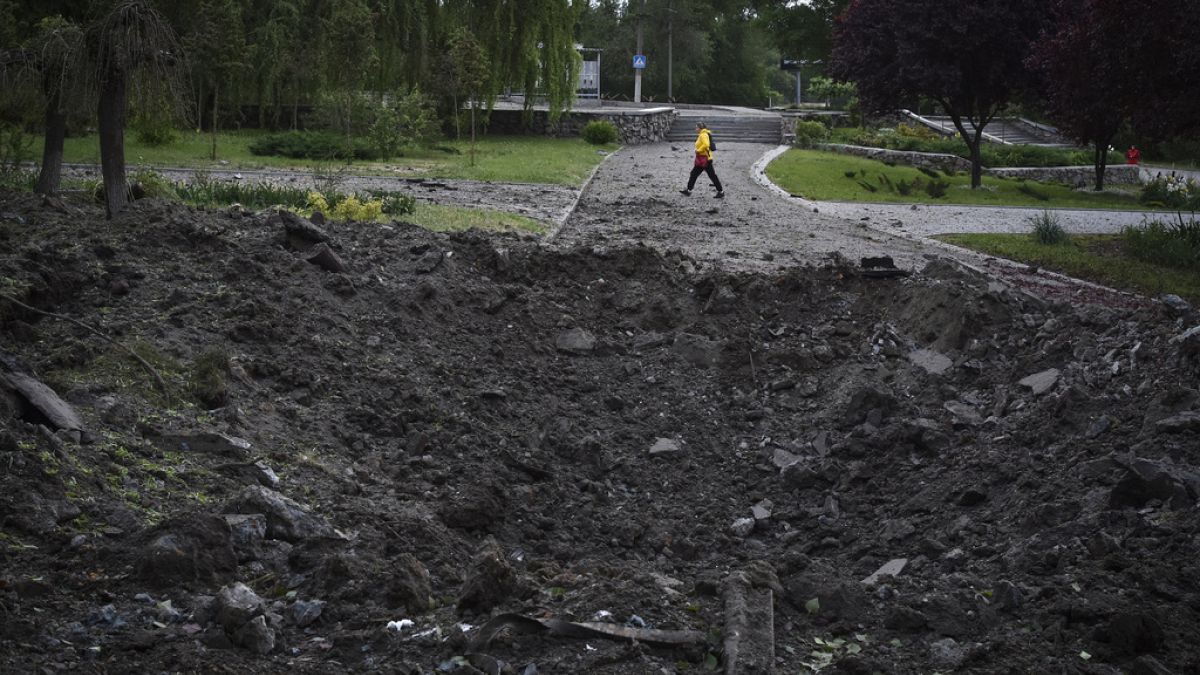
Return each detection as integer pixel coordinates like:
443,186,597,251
833,0,1046,187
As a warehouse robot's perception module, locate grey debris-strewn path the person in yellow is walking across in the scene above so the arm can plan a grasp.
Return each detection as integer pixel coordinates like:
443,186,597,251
554,143,937,269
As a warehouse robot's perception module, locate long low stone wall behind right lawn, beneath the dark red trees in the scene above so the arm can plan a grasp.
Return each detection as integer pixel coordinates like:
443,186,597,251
817,143,1141,187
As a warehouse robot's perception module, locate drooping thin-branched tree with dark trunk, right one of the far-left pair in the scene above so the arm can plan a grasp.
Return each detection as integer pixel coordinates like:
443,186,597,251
86,0,181,219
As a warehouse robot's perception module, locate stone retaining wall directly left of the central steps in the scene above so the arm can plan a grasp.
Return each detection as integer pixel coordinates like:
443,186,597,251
487,108,678,145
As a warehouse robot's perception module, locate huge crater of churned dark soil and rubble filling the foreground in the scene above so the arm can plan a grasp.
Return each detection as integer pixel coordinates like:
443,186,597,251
0,195,1200,674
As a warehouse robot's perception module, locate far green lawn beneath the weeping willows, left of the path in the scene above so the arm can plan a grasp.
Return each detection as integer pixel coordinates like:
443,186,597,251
51,131,616,186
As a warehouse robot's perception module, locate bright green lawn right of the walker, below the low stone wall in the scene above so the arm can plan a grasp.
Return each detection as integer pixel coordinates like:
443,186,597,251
767,148,1148,210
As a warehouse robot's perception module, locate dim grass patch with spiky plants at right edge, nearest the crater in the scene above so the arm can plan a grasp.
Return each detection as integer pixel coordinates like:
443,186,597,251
935,234,1200,303
